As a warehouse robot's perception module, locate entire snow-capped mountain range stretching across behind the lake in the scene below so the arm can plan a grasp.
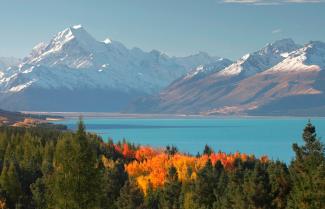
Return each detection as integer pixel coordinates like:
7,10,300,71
0,25,325,116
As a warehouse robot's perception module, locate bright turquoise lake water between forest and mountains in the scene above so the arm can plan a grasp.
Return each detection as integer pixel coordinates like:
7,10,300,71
55,118,325,162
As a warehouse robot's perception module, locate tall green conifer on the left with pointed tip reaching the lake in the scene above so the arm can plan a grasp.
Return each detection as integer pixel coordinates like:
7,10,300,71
51,120,102,209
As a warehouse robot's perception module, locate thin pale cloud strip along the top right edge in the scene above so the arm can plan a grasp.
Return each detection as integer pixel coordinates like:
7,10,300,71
218,0,325,5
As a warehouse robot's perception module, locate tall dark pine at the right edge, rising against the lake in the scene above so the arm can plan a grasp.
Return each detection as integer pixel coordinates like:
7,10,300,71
288,121,325,209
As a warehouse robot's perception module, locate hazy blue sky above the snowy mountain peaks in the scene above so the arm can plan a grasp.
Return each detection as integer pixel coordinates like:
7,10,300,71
0,0,325,59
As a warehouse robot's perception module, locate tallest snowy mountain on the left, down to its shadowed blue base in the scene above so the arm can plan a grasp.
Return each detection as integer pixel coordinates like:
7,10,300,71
0,25,217,111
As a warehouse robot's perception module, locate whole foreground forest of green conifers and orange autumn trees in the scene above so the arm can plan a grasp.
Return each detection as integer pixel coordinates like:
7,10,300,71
0,121,325,209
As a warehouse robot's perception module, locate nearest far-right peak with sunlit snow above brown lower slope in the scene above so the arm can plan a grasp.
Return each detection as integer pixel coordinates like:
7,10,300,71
206,41,325,114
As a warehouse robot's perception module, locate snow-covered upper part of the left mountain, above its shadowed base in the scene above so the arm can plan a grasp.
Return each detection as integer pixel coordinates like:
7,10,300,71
0,26,212,94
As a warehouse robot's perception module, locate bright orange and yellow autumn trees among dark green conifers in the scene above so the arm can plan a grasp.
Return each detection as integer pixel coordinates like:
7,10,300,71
125,147,267,192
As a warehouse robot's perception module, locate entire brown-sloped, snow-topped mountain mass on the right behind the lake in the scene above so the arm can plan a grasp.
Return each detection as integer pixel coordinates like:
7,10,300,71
130,39,325,115
